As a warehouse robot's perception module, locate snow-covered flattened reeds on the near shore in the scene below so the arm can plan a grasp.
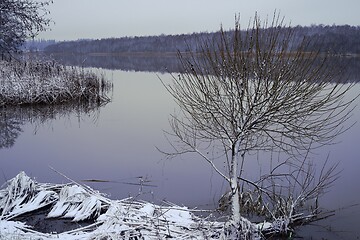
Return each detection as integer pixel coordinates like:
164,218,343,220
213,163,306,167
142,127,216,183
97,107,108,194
0,172,264,240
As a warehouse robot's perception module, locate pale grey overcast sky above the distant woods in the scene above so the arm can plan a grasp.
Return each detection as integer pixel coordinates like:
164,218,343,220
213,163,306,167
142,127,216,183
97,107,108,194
39,0,360,40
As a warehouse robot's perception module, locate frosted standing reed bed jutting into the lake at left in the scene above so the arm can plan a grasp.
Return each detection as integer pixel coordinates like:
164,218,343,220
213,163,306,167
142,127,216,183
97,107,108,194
0,60,111,106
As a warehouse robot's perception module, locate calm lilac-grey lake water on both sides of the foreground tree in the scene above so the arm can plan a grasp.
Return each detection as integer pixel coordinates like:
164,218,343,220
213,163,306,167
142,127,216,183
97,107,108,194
0,57,360,239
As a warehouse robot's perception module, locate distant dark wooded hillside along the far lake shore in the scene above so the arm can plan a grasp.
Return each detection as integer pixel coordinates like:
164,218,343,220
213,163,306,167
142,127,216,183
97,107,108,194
44,25,360,54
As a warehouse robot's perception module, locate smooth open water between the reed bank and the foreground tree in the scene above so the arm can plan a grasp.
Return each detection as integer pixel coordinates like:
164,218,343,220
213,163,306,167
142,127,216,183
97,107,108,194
0,71,224,205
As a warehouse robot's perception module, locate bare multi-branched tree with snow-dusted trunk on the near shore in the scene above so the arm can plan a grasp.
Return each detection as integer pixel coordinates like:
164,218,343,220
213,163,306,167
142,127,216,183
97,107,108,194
163,14,358,234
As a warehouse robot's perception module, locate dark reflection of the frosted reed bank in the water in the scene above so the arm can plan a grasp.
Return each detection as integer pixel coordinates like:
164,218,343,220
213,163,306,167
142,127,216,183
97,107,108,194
0,103,100,149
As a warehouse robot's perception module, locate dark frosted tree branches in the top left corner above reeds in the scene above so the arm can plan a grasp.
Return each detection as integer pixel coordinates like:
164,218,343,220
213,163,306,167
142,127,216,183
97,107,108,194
0,0,52,57
